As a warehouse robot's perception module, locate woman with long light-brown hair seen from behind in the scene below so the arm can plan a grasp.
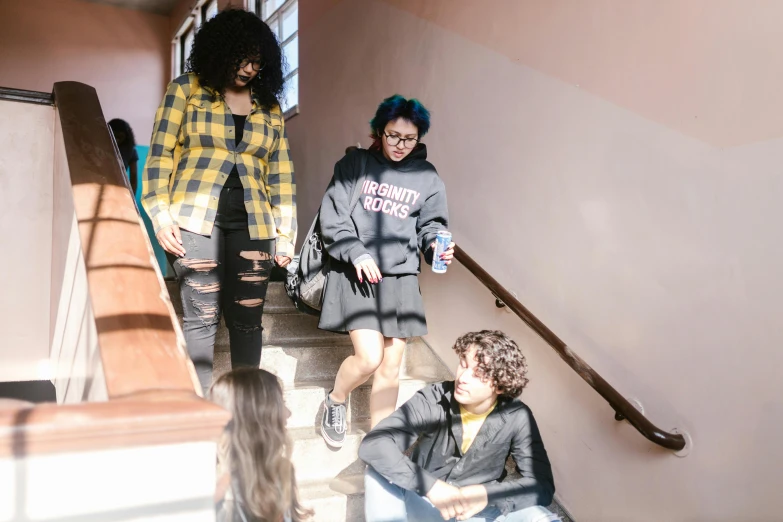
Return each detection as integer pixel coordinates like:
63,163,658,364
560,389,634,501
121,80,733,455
209,368,312,522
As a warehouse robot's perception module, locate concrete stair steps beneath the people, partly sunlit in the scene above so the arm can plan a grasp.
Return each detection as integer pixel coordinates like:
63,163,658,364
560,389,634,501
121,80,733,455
167,281,451,522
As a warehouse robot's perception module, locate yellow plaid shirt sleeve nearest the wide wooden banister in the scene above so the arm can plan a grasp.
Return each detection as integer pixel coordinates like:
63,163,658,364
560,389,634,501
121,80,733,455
141,78,189,234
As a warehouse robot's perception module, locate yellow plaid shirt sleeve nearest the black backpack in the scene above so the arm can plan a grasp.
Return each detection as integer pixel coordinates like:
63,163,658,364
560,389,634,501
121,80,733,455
266,108,297,257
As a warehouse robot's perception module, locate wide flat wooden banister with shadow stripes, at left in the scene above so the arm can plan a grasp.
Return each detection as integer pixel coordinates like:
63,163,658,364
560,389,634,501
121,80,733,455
0,82,230,458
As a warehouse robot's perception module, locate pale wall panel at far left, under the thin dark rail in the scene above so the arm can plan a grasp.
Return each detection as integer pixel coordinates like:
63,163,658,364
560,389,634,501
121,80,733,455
0,101,55,382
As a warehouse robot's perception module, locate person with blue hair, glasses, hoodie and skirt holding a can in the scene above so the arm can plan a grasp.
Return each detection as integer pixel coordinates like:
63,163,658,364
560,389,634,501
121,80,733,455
318,95,454,448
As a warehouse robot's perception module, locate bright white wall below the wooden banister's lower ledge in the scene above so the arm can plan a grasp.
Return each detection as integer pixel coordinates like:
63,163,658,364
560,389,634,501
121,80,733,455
0,442,216,522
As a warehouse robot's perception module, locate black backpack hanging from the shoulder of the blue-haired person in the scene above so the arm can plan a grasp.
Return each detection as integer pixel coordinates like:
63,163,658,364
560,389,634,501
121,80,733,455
285,151,368,315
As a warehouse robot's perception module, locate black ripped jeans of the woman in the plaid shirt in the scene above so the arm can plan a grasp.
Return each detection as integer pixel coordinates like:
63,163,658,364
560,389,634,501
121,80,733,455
169,226,275,392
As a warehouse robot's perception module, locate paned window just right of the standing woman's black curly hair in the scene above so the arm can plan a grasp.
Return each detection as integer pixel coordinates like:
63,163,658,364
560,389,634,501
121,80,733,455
248,0,299,116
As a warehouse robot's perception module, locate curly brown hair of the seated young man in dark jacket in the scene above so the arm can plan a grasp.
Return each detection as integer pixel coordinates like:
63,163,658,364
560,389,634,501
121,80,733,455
454,330,529,398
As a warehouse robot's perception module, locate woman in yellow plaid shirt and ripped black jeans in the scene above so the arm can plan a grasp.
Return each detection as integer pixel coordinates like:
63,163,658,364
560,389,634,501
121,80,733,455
142,9,296,390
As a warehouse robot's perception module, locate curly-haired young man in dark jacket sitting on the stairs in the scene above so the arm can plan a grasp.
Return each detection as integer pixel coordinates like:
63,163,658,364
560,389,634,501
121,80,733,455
359,330,560,522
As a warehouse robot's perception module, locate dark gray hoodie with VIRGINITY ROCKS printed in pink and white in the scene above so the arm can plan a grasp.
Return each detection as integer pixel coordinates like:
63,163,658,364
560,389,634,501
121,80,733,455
320,144,449,275
